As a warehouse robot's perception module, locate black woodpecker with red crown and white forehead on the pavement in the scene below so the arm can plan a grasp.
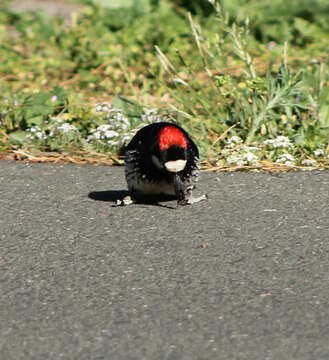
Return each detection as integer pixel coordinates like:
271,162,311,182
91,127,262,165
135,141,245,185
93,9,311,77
121,122,206,205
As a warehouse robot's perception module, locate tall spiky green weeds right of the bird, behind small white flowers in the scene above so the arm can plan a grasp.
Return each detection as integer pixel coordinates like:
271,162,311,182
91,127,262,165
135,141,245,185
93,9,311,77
152,4,329,163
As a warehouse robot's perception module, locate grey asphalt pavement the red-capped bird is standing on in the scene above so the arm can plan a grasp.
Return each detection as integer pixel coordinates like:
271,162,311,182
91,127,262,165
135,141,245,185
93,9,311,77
0,161,329,360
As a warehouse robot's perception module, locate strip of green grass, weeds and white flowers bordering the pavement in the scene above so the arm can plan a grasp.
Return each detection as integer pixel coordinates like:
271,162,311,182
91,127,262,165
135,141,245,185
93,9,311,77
0,0,329,169
